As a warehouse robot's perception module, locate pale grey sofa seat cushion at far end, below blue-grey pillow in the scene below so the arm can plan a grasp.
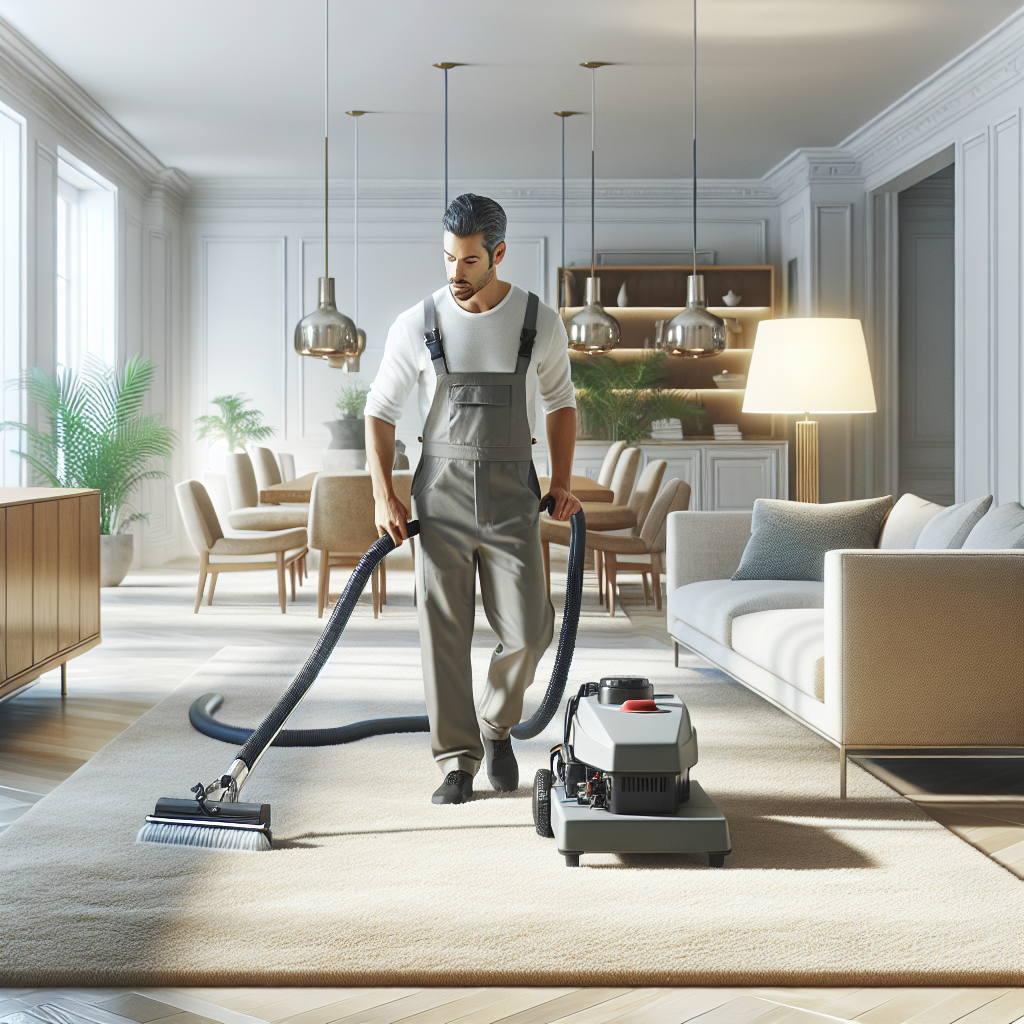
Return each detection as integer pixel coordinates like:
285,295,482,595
669,580,825,647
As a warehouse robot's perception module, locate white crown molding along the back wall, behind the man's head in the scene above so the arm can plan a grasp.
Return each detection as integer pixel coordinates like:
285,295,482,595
187,178,774,211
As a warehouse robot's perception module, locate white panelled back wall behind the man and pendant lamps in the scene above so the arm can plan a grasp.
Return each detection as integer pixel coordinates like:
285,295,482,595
187,181,777,476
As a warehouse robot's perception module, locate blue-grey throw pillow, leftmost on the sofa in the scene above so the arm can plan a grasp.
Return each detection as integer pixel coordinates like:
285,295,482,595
732,495,893,581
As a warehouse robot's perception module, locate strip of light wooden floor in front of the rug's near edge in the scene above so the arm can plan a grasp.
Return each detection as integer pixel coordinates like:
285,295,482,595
0,988,1024,1024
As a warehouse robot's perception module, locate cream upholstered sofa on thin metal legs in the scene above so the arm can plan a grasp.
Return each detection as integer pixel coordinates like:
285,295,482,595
666,496,1024,798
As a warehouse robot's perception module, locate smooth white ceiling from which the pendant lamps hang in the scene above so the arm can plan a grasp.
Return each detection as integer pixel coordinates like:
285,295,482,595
0,0,1020,180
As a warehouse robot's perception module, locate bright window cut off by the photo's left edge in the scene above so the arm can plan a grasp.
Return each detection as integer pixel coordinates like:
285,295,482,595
0,104,25,487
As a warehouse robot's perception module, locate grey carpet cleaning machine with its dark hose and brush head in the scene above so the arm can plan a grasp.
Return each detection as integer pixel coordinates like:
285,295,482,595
137,496,730,867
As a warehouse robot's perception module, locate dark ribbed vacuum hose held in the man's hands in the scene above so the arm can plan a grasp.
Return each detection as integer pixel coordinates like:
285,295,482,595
188,495,587,770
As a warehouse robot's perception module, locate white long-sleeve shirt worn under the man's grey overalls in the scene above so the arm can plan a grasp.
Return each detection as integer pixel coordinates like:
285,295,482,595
367,285,575,433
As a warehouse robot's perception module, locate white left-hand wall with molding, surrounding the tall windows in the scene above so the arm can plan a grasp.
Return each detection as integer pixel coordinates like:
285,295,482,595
0,22,188,565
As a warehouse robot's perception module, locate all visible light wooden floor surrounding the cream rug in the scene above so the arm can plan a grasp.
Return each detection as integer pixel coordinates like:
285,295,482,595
0,568,1024,1024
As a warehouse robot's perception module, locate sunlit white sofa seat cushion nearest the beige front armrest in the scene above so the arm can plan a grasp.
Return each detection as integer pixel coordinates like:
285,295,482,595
732,608,825,702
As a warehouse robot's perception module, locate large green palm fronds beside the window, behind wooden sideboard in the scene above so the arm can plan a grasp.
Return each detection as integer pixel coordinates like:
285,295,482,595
2,355,177,534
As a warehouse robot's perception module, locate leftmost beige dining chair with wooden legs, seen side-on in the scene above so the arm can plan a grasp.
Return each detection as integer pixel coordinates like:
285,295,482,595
174,480,306,614
